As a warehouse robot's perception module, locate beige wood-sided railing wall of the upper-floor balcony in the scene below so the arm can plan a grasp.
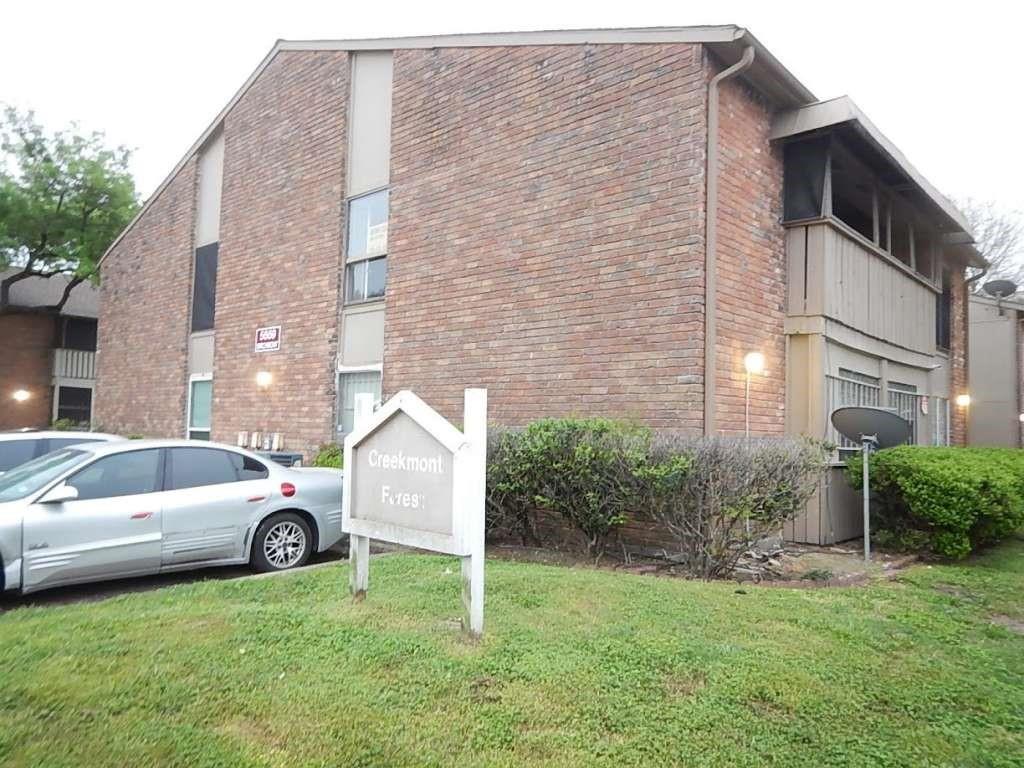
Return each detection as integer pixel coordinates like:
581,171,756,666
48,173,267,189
785,218,940,355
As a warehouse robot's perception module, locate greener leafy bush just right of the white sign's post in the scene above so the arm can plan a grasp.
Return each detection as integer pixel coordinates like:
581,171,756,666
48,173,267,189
487,419,650,557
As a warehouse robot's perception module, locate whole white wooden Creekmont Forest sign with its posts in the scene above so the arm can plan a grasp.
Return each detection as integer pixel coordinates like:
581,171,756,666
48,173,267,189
342,389,487,635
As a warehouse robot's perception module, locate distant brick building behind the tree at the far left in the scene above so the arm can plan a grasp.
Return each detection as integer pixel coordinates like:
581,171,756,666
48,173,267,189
0,268,99,429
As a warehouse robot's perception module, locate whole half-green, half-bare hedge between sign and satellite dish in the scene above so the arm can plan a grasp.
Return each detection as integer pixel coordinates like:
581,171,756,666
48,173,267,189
487,419,826,578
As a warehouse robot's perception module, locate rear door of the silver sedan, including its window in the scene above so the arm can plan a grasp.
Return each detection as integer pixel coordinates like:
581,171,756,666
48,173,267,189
161,446,270,566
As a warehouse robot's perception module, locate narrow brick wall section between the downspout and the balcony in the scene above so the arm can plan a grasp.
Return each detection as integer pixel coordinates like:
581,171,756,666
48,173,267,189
707,59,785,434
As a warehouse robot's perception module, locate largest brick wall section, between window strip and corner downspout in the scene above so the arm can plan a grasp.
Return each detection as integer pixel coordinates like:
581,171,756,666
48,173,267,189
384,45,706,431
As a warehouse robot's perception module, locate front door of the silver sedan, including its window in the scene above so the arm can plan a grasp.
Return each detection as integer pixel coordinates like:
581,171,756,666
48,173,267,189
22,449,163,592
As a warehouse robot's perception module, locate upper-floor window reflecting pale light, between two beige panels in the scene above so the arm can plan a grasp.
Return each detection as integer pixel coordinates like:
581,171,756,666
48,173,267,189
345,189,388,303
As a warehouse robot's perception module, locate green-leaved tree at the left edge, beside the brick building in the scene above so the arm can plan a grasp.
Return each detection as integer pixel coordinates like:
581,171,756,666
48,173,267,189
0,108,138,312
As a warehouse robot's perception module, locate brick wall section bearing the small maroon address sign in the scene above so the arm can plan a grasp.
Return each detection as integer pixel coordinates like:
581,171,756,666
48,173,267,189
212,51,348,454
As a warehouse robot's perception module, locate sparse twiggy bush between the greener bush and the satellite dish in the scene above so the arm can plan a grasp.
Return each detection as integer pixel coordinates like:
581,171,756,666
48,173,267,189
639,435,828,579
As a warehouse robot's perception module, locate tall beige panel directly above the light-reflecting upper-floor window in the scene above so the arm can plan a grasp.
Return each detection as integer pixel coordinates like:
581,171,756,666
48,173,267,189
348,51,392,197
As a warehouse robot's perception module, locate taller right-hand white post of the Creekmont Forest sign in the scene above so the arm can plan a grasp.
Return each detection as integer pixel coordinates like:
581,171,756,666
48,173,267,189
462,389,487,637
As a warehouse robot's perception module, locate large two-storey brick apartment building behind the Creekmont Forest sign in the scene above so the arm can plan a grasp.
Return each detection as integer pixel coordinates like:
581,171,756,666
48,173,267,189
96,27,981,542
